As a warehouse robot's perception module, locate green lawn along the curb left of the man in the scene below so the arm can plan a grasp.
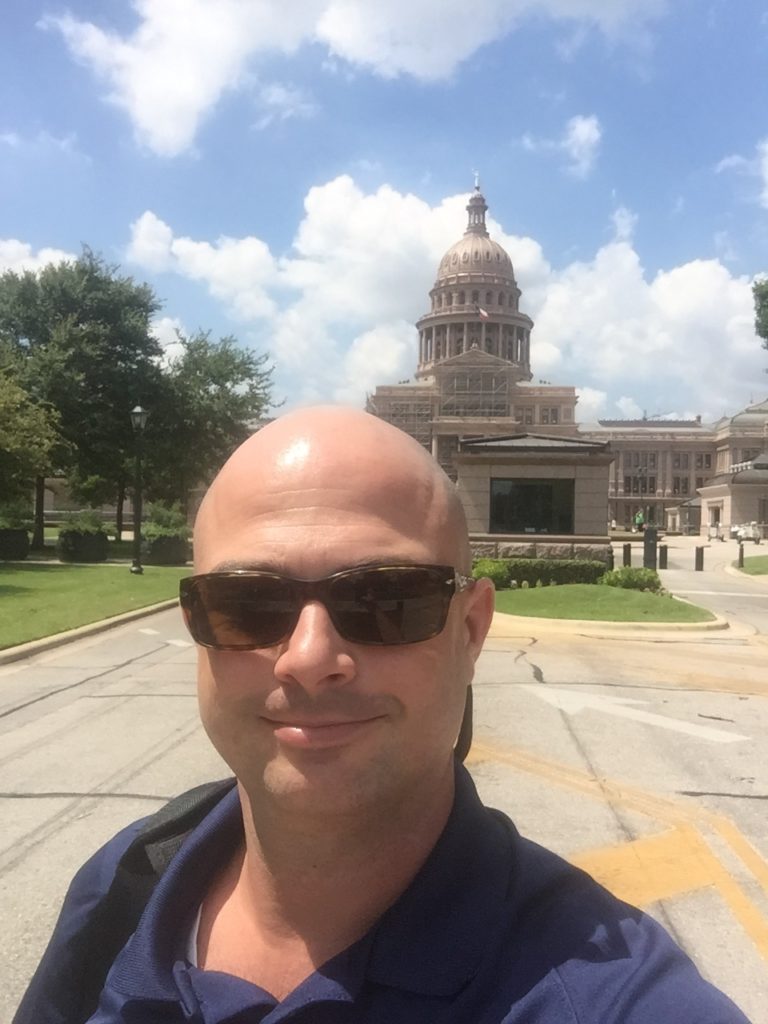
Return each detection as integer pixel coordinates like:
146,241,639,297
0,562,191,649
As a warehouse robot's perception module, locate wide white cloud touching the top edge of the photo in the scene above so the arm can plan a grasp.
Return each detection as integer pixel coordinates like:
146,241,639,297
40,0,667,157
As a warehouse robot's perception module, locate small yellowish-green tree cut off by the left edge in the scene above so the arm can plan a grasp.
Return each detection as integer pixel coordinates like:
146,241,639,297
0,372,58,502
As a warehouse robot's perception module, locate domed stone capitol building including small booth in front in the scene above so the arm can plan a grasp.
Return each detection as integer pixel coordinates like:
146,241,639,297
367,185,768,554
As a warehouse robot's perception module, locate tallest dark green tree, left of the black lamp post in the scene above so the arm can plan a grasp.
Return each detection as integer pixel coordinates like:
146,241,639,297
0,248,162,545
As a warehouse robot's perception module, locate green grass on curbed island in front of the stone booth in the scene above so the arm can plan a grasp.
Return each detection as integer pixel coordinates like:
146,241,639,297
496,583,715,623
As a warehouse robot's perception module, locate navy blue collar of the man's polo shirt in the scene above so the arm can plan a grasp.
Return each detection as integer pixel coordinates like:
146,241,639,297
109,765,514,1000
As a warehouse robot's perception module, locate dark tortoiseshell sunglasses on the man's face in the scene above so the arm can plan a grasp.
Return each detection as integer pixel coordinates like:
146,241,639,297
179,565,475,650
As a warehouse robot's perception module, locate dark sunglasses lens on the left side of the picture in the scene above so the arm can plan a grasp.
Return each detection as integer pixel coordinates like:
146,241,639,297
181,573,296,650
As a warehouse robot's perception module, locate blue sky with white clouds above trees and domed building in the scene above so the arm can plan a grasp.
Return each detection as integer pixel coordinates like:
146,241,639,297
0,0,768,420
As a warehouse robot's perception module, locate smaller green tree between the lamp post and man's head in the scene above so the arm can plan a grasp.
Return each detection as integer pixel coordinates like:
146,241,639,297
144,331,272,507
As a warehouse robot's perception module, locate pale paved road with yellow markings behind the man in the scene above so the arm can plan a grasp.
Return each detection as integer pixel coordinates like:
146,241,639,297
0,548,768,1024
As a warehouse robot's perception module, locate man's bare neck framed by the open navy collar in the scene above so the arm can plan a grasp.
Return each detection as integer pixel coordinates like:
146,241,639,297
199,771,454,997
